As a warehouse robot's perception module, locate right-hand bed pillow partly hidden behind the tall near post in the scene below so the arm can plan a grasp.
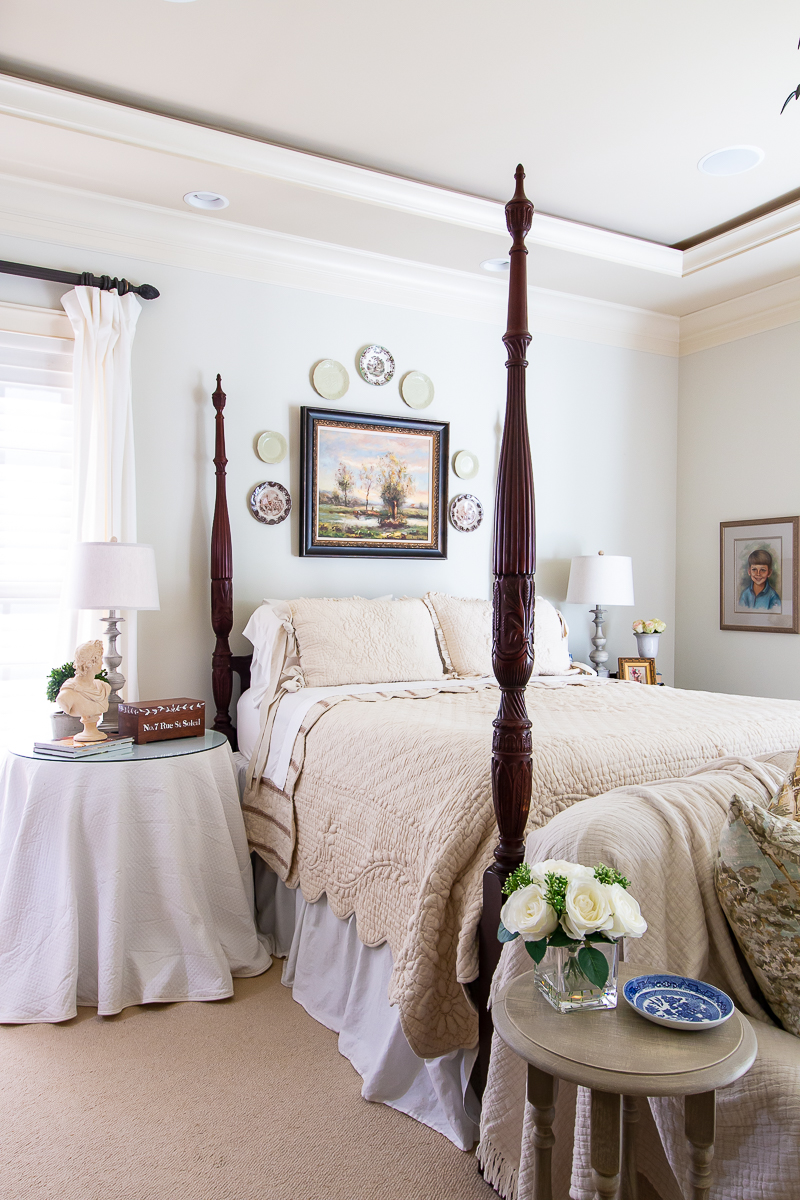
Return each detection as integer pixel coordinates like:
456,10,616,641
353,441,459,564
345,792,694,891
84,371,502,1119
423,592,570,676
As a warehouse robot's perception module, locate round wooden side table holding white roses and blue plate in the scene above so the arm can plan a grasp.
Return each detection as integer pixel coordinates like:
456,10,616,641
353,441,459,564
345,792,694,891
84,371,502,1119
492,964,757,1200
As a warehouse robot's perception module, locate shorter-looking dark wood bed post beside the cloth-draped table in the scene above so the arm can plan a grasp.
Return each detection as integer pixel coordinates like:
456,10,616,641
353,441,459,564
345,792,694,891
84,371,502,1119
211,376,252,750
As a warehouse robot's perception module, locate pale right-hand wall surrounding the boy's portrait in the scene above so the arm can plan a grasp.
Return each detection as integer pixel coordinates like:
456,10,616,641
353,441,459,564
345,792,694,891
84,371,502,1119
675,324,800,700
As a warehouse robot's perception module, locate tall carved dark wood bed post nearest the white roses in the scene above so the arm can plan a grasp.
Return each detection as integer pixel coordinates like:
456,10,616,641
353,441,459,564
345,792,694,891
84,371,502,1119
474,166,536,1092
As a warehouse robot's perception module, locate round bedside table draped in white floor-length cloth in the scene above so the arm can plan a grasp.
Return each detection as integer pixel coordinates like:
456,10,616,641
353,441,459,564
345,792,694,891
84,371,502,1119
0,731,271,1022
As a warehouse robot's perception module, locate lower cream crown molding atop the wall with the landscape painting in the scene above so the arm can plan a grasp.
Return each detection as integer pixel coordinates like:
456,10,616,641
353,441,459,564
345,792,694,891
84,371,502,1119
0,175,679,355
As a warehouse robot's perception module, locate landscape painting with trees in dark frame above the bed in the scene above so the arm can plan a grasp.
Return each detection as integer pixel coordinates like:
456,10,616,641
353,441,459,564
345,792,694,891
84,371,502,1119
300,408,449,558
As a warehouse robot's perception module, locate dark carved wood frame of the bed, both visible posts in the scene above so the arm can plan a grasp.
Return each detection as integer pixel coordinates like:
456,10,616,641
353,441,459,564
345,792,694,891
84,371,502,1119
211,174,536,1076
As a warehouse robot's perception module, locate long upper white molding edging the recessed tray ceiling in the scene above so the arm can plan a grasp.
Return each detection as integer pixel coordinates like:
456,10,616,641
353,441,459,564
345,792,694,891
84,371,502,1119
0,74,682,276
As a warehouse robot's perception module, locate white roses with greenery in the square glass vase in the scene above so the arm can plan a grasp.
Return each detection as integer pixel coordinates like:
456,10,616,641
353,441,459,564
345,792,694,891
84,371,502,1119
498,858,648,988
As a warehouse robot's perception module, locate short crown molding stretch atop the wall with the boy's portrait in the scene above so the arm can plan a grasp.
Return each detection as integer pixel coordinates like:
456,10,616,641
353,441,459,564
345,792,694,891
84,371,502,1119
680,276,800,356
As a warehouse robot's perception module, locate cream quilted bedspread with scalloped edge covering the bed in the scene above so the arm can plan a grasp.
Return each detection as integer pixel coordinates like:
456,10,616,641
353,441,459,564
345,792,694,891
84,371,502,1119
243,679,800,1057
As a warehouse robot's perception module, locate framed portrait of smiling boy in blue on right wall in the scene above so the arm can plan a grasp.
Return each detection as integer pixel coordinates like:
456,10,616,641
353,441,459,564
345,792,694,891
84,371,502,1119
720,517,800,634
